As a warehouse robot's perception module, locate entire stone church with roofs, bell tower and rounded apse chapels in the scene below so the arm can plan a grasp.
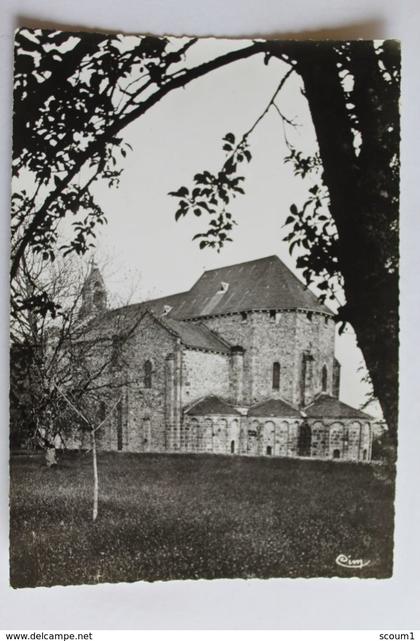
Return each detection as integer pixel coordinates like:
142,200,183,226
76,256,373,462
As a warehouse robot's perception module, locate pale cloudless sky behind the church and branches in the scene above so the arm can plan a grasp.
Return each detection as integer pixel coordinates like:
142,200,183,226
41,38,378,413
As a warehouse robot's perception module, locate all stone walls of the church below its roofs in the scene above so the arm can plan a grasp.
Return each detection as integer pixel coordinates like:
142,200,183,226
65,304,372,461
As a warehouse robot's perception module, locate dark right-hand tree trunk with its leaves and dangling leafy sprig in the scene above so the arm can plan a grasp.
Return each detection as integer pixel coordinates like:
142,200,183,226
172,41,400,442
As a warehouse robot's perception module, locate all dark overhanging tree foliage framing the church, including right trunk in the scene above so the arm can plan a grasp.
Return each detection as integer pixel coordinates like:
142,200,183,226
11,29,400,441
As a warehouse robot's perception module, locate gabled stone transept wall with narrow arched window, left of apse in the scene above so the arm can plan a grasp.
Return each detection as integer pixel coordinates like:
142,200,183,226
74,315,179,452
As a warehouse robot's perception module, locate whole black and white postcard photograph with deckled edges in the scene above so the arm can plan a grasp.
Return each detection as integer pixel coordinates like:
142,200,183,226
10,27,400,588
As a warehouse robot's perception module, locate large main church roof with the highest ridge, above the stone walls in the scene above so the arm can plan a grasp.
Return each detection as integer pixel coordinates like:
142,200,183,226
85,256,332,342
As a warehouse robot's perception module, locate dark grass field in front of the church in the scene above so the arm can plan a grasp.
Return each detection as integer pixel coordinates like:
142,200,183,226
10,453,393,587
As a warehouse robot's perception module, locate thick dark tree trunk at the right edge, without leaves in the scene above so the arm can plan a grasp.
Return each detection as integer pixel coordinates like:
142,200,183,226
288,42,399,442
